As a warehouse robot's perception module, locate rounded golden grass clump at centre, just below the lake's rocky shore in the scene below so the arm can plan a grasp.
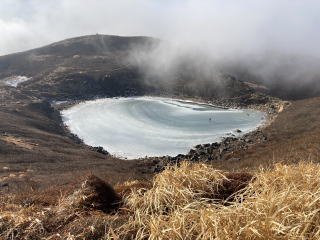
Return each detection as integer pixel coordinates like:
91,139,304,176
126,162,241,214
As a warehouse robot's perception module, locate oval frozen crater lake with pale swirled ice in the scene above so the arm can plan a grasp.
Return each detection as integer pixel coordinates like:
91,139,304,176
62,97,264,159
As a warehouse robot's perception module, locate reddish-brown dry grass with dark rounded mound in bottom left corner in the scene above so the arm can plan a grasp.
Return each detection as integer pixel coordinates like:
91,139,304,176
0,175,126,240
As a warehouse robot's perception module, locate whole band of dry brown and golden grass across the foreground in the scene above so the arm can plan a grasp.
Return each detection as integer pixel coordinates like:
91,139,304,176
0,163,320,240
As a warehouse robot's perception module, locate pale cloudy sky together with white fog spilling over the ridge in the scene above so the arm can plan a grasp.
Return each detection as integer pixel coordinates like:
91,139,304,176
0,0,320,98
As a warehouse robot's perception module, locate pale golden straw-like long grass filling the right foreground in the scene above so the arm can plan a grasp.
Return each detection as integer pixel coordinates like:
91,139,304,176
108,163,320,239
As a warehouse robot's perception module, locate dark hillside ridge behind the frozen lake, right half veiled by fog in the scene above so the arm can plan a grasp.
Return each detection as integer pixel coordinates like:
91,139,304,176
0,34,320,100
